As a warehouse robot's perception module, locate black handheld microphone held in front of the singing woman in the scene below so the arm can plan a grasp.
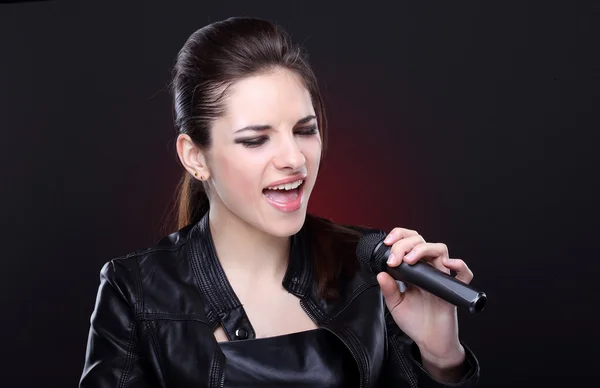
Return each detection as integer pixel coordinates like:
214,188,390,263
356,232,487,313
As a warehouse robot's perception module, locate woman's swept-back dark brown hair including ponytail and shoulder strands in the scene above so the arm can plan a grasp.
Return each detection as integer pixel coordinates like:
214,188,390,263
171,17,358,299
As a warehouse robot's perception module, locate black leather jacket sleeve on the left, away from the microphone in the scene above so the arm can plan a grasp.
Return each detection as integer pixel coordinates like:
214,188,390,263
79,260,151,388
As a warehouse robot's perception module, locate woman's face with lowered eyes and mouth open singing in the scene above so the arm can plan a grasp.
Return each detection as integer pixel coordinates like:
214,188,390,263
206,69,321,236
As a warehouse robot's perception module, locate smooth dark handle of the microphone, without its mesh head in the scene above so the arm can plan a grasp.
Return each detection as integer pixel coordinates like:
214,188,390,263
383,261,487,313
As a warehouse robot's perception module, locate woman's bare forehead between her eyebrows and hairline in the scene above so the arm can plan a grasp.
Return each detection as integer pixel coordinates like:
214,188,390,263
225,69,314,128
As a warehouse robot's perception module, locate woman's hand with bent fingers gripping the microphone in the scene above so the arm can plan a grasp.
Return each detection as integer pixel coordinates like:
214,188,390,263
377,228,473,373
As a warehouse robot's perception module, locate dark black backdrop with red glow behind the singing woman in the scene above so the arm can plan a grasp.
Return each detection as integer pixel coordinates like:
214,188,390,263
0,1,600,387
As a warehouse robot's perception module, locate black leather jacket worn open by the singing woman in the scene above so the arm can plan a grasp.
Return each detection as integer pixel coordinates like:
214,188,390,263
80,216,479,388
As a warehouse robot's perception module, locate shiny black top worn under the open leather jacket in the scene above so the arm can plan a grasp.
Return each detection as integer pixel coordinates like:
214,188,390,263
220,329,359,388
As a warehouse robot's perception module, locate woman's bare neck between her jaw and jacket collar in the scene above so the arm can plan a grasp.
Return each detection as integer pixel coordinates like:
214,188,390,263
209,206,290,283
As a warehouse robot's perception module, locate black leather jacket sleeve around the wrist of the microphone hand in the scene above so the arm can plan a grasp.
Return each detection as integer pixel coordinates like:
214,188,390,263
382,309,480,388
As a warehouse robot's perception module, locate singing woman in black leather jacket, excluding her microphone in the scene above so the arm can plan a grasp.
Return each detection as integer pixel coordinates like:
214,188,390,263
80,18,479,388
